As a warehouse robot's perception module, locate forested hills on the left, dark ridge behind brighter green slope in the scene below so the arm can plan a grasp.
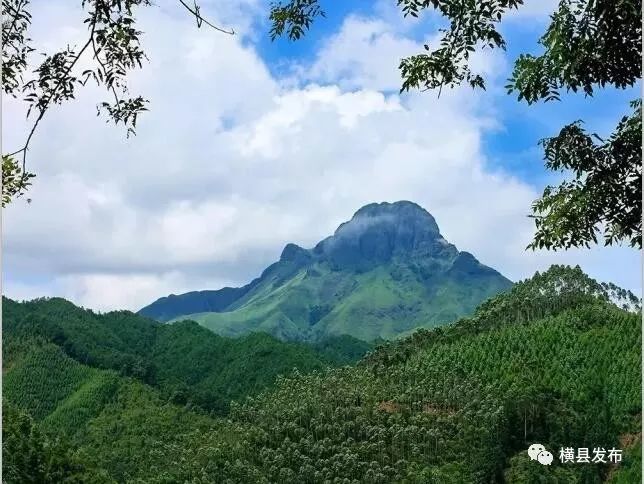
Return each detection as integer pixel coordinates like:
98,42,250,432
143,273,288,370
2,298,371,483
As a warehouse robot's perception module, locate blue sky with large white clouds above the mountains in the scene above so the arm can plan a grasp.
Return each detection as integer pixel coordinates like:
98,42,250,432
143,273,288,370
2,0,641,311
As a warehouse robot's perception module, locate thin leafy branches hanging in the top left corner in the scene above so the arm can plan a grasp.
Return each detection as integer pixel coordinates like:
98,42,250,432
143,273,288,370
2,0,234,206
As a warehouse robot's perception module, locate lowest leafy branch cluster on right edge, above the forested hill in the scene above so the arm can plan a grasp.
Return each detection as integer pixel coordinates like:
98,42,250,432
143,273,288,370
529,99,642,249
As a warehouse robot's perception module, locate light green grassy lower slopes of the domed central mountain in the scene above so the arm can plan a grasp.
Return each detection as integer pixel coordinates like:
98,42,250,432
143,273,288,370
175,264,509,341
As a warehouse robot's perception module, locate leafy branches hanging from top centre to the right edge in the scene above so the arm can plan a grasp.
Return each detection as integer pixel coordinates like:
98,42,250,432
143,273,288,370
270,0,642,250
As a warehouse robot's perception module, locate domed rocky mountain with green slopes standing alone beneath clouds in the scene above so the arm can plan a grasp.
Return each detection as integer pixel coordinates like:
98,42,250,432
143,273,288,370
140,201,512,341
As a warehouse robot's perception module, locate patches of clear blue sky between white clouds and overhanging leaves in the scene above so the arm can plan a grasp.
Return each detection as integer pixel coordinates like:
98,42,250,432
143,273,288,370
256,1,640,188
